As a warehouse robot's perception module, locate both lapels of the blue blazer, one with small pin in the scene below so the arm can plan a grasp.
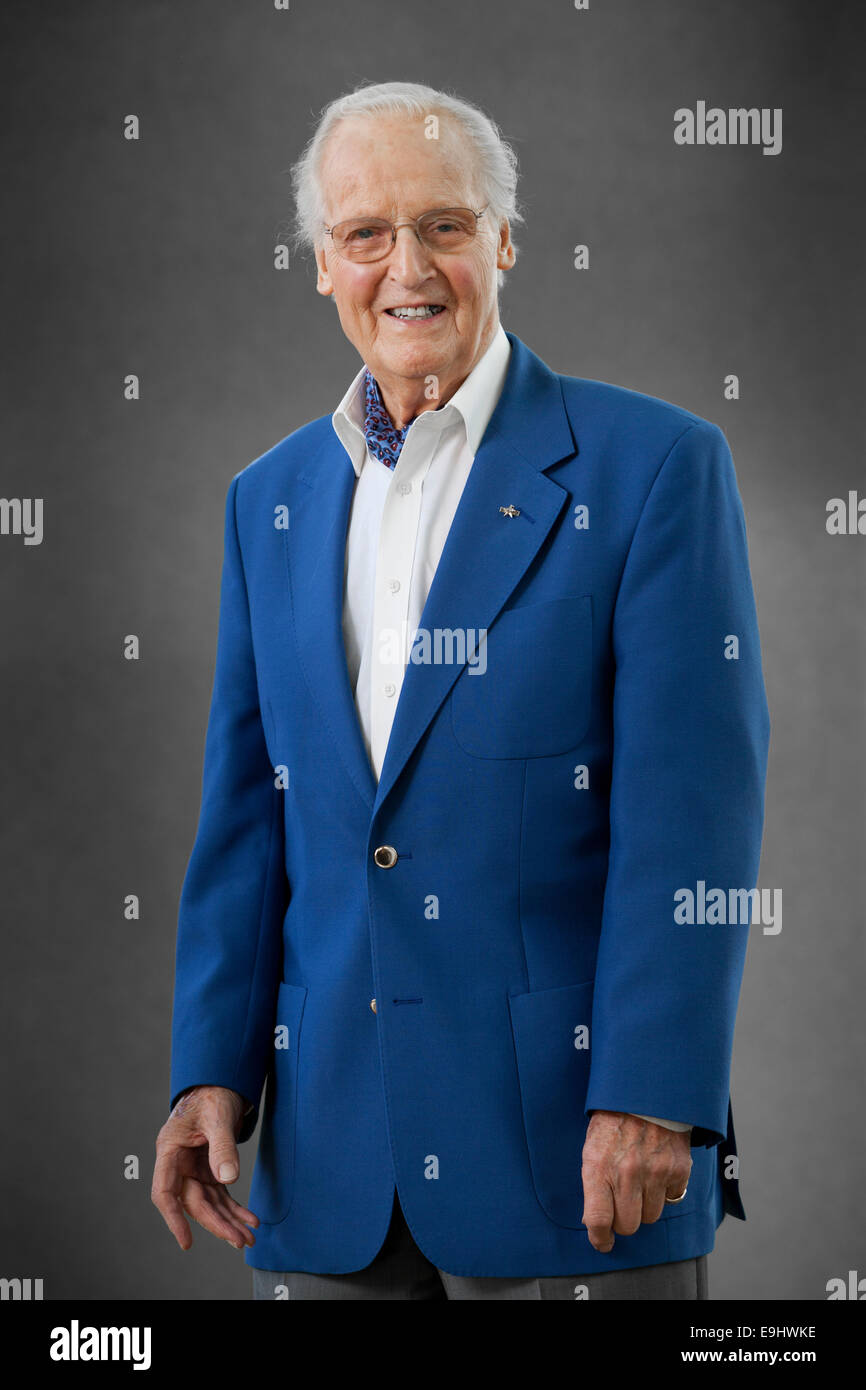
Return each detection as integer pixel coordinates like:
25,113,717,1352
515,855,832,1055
285,334,577,810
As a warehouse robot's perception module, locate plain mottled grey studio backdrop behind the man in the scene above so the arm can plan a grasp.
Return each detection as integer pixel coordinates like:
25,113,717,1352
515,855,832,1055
0,0,866,1300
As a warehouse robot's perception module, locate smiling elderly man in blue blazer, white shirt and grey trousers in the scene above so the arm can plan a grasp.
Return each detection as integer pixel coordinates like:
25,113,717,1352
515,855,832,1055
153,82,769,1300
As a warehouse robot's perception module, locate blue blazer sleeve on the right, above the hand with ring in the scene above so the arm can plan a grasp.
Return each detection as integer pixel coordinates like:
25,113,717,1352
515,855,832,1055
585,421,770,1145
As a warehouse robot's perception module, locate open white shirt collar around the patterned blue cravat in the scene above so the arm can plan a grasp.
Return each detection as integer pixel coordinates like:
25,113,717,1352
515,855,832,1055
331,324,512,475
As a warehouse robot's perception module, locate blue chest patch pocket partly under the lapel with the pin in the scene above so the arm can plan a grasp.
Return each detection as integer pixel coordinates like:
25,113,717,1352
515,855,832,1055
450,594,592,758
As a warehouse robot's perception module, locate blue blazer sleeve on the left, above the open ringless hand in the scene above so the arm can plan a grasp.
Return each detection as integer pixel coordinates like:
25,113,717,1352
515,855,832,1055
171,474,288,1141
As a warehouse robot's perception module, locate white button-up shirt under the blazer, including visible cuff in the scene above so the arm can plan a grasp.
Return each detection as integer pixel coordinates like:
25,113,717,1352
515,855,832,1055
332,324,691,1130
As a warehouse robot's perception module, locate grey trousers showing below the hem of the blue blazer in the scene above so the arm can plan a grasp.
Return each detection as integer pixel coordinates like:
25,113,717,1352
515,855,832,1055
252,1193,708,1302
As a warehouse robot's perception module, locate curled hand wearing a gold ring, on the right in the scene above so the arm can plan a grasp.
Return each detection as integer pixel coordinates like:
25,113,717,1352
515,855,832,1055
582,1111,692,1255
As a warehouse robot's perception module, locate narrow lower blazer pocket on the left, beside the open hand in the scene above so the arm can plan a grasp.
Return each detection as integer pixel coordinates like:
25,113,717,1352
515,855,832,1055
249,981,307,1226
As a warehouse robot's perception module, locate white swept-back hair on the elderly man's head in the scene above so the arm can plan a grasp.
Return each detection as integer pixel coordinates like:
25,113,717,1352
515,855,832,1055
291,82,524,288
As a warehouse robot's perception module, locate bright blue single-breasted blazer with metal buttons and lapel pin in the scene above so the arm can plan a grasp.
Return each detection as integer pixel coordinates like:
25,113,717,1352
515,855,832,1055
171,334,769,1277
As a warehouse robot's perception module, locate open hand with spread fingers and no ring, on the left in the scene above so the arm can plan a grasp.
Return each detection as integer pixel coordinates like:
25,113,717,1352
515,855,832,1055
150,1086,259,1250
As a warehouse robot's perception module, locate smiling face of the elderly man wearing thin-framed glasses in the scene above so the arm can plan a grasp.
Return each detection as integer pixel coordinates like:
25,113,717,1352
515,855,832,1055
316,115,514,391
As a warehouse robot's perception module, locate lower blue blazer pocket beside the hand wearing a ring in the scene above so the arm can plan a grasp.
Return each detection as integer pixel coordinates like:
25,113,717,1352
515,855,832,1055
509,980,594,1227
